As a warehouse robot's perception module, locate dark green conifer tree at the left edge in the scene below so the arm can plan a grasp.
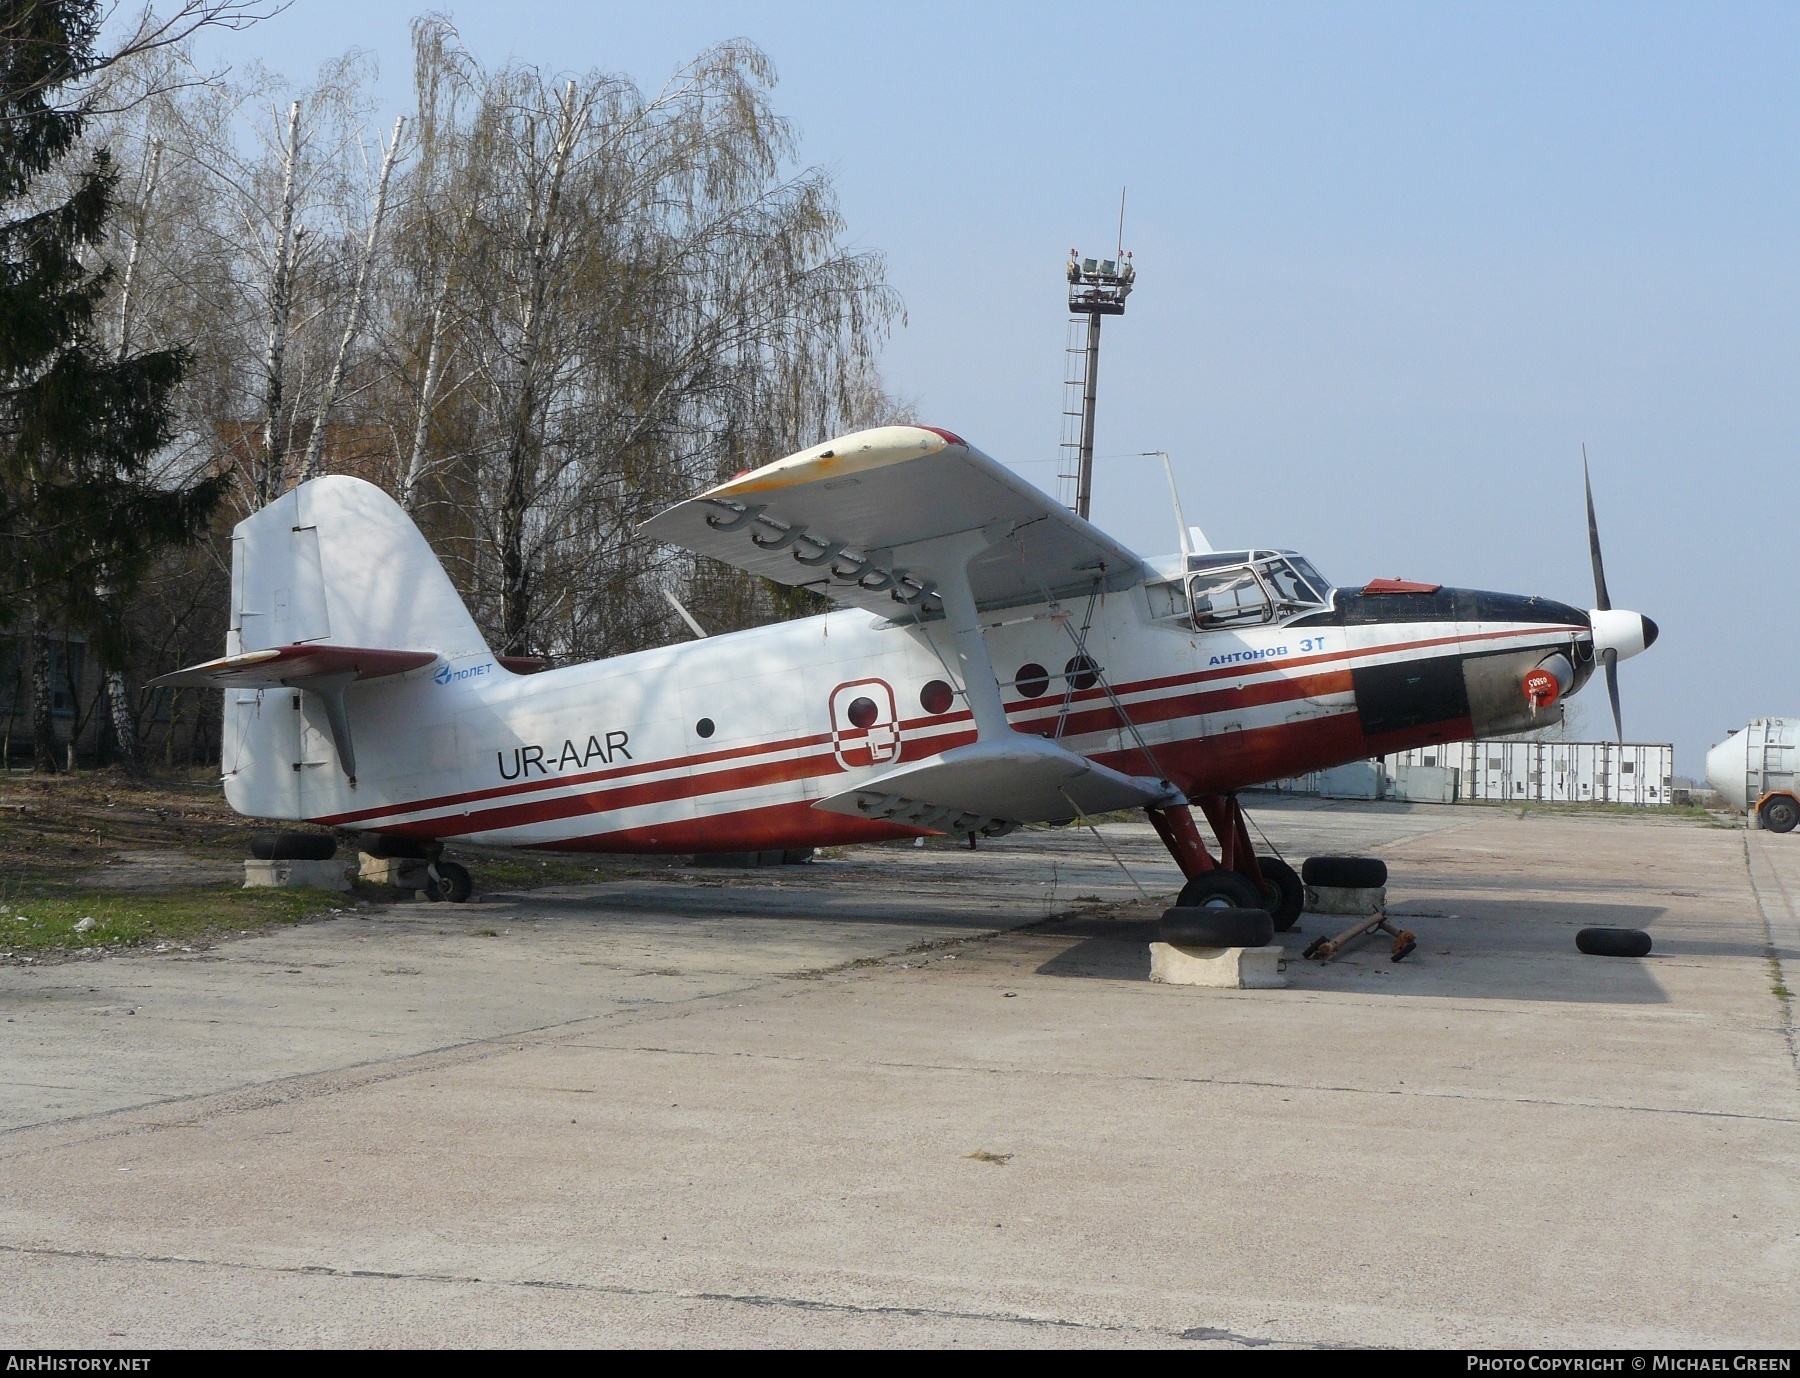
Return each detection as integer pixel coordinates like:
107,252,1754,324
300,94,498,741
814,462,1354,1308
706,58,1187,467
0,0,225,770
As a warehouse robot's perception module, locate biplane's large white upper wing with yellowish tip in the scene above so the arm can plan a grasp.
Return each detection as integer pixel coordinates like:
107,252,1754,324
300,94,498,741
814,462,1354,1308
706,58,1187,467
643,426,1147,617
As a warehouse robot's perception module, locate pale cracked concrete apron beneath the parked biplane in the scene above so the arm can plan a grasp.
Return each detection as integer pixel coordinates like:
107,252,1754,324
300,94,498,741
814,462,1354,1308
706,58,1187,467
0,808,1800,1346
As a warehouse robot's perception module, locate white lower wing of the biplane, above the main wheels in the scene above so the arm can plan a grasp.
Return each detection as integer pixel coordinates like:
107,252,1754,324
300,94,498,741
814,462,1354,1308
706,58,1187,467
814,732,1181,835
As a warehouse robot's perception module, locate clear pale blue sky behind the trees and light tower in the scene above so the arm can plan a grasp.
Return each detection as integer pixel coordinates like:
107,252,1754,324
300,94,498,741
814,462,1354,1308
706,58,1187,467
189,0,1800,774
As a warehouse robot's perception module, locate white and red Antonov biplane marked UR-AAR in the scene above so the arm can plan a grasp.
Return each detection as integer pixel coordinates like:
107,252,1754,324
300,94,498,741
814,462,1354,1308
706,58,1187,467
162,426,1656,928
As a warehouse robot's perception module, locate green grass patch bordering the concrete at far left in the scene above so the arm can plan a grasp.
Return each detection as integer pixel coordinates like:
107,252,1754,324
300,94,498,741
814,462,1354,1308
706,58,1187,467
0,889,356,957
